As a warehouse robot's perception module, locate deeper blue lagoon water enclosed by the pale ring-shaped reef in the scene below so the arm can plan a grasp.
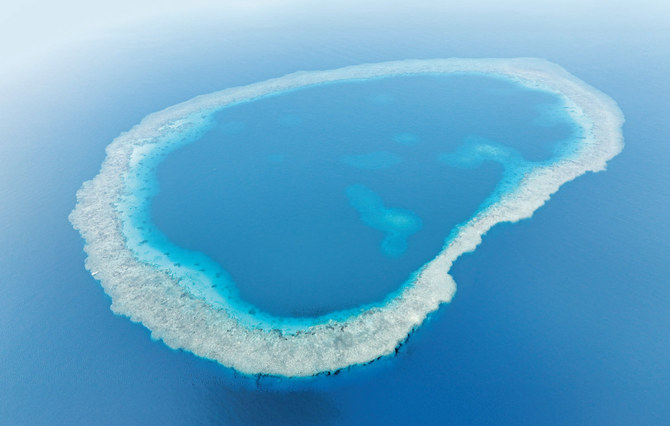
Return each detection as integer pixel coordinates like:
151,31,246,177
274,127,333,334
151,76,576,316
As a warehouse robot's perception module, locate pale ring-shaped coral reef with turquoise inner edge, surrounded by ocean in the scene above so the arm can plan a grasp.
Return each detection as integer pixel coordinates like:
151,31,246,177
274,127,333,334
70,58,624,377
